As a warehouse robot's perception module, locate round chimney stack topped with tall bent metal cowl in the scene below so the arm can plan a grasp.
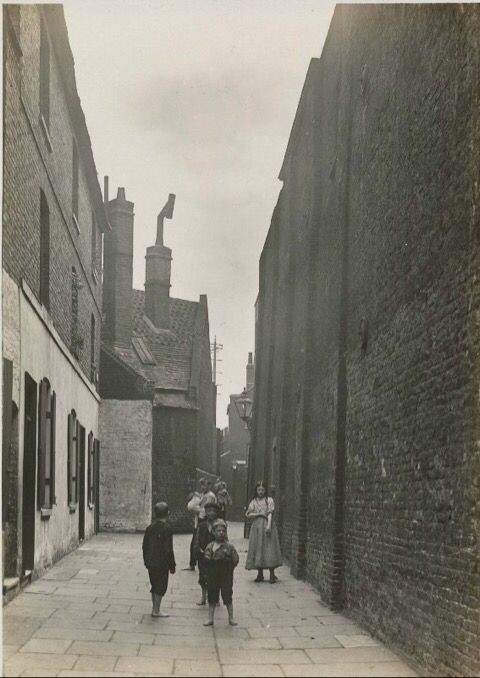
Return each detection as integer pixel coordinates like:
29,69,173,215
145,193,175,330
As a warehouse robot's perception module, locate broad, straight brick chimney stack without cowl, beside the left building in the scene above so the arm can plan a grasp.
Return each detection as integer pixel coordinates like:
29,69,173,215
103,186,134,348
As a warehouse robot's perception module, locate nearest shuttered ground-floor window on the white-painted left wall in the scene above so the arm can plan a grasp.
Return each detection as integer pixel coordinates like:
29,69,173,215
38,379,56,511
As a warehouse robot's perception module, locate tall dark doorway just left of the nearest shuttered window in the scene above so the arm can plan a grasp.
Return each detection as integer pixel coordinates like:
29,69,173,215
22,373,37,574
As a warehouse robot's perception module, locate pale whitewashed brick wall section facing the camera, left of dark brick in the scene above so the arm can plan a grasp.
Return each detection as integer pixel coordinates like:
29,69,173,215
100,400,152,531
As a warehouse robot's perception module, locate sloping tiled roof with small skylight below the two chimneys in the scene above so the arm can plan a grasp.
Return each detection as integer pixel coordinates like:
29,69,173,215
110,290,198,390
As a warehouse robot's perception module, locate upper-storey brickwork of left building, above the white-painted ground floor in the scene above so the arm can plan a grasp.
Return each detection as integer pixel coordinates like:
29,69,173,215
3,5,102,388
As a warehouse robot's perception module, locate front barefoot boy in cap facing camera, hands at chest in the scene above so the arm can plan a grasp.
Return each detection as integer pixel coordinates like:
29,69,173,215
204,519,239,626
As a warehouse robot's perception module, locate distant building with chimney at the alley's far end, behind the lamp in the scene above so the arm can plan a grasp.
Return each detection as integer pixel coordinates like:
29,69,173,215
220,353,255,520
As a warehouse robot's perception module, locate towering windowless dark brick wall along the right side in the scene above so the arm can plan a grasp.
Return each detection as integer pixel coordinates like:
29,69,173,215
251,5,480,676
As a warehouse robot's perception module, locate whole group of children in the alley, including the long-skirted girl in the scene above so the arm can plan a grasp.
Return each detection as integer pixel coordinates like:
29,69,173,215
143,483,282,626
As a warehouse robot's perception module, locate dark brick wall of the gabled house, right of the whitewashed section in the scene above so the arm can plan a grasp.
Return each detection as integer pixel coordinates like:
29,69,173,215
151,407,197,532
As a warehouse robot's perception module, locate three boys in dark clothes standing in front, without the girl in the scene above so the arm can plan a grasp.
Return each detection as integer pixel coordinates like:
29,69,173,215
143,502,239,626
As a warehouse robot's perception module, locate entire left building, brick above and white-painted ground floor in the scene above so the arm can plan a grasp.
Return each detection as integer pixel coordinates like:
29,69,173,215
2,5,108,592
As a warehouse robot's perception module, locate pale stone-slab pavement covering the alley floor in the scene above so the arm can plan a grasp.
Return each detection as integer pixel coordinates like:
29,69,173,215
4,524,416,678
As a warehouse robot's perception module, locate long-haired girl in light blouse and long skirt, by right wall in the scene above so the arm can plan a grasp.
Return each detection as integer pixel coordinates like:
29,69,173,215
245,483,282,584
